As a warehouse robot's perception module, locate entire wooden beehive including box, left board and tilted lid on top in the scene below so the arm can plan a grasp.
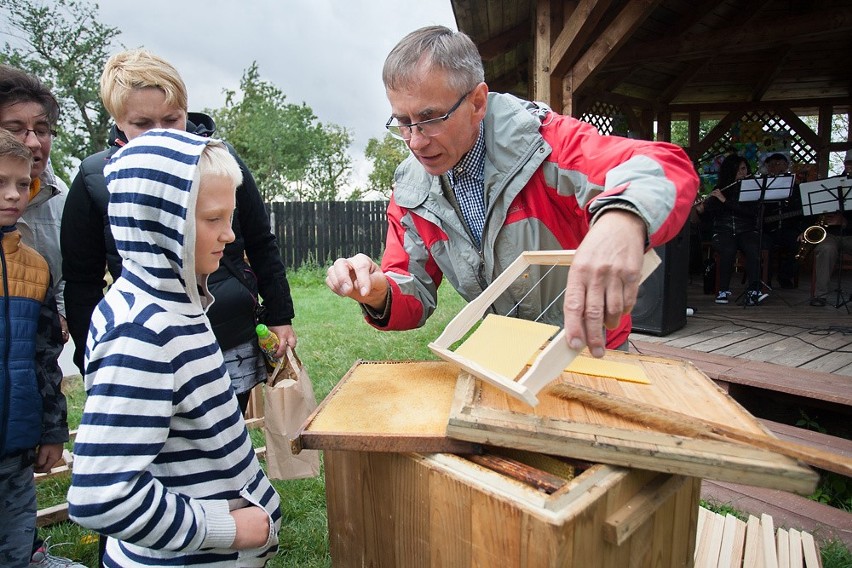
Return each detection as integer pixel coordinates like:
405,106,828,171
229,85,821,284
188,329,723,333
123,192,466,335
294,360,816,568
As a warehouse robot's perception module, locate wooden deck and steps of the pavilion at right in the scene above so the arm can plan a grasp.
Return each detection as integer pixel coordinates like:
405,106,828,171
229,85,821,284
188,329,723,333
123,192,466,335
630,275,852,549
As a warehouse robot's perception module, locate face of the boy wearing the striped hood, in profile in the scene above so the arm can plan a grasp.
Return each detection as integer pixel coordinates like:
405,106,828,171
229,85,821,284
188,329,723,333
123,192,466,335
195,176,237,274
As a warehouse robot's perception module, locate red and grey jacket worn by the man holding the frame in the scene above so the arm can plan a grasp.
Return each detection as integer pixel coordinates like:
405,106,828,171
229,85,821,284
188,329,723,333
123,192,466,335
374,93,698,347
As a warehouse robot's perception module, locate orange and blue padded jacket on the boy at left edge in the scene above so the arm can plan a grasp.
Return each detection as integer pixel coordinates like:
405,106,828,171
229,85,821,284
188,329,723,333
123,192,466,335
0,226,68,458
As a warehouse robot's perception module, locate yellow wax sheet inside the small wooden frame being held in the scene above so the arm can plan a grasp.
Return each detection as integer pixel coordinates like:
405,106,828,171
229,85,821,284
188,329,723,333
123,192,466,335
455,314,559,379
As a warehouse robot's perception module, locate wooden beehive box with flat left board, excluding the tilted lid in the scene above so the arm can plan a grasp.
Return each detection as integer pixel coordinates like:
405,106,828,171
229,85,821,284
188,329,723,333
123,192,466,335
296,361,700,568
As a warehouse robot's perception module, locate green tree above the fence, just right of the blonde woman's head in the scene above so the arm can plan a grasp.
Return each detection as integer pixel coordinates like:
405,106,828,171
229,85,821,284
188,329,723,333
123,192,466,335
207,62,352,201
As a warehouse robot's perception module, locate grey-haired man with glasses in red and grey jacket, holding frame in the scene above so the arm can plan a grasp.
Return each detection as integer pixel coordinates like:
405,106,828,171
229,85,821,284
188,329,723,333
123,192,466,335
326,26,698,357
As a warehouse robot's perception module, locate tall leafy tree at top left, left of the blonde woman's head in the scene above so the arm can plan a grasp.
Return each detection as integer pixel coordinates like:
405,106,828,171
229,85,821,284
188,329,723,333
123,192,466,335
0,0,121,180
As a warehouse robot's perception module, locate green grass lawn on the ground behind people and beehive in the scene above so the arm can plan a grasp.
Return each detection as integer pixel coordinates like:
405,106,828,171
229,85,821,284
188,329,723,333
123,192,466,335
38,267,852,568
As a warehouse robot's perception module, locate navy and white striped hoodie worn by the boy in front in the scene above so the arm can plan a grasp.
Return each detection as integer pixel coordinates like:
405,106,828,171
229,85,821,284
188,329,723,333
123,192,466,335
68,130,281,567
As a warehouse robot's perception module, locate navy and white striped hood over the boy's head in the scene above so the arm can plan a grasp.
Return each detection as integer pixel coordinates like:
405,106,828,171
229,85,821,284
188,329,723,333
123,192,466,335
104,129,223,305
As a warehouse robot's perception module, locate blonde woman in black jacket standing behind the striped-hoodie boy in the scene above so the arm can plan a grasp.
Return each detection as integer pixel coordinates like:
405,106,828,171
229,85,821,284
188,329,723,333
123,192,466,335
61,49,296,410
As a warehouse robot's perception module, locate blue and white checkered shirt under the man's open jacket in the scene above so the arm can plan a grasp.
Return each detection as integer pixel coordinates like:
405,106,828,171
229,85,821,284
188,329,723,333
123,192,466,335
447,123,485,247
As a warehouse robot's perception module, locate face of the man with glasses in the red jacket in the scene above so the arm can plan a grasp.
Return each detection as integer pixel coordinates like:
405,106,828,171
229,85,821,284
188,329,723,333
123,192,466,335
386,69,488,175
